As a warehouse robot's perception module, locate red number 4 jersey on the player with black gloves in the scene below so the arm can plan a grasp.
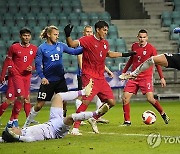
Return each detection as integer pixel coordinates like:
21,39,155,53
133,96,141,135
79,35,109,79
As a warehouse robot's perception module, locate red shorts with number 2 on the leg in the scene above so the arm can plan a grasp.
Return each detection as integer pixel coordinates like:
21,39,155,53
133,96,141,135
124,77,154,95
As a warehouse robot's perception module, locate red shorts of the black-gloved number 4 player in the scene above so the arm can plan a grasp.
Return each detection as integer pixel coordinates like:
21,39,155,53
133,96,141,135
82,75,114,102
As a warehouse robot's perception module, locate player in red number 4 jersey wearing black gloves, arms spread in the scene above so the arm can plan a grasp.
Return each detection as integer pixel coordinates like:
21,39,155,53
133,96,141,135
64,21,135,135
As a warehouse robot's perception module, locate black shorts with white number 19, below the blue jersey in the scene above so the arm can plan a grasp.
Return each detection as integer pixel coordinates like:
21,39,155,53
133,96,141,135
37,79,68,101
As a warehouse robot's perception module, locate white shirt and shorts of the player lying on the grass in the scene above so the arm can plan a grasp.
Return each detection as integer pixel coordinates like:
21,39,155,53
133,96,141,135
20,107,70,142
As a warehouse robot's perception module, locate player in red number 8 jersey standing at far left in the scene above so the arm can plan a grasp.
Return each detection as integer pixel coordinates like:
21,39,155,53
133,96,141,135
0,28,37,127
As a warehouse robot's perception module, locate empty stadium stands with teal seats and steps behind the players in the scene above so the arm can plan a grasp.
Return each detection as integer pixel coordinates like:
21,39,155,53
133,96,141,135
0,0,180,100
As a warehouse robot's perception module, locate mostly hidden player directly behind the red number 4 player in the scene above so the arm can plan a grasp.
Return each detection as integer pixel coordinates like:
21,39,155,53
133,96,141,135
74,25,113,126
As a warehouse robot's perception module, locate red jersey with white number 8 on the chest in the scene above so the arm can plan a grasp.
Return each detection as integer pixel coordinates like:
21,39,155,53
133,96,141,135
7,43,37,75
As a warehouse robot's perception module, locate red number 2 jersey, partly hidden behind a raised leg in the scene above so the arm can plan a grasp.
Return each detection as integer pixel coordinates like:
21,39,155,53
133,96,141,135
123,42,163,78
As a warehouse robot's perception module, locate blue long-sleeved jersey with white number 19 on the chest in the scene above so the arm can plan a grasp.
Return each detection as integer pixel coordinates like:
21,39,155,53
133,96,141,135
35,42,83,81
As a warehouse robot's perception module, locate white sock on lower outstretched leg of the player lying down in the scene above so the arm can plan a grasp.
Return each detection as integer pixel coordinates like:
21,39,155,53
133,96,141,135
72,112,93,121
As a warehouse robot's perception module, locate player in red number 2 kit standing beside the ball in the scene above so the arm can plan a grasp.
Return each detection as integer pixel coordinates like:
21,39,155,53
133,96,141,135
119,29,169,126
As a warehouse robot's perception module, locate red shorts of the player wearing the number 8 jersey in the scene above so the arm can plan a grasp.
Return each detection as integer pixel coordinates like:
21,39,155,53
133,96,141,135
6,74,31,100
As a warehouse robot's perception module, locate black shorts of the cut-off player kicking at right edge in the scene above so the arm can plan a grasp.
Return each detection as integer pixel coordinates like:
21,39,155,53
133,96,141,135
164,53,180,70
